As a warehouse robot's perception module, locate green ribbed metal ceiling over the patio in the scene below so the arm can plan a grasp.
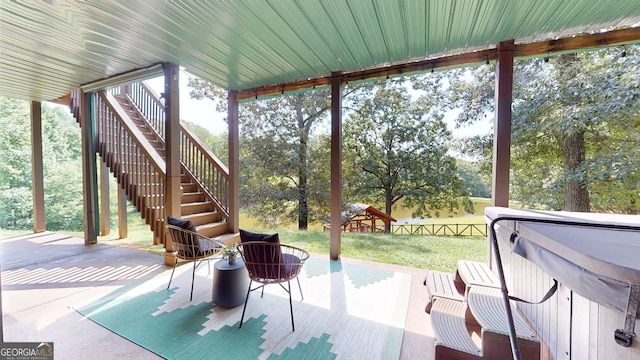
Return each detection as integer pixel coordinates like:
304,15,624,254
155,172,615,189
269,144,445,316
0,0,640,101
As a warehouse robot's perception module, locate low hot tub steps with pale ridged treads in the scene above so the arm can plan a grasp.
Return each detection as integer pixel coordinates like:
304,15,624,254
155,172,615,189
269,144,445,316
425,260,541,360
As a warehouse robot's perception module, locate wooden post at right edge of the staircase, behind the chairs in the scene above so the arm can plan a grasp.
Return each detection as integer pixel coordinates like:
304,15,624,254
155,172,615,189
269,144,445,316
227,91,240,233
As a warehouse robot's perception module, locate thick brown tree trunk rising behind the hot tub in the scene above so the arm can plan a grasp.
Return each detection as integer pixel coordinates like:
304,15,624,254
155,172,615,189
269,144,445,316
562,131,590,212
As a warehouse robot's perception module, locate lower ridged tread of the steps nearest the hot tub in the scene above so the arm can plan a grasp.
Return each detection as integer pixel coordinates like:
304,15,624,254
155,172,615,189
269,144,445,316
467,286,539,341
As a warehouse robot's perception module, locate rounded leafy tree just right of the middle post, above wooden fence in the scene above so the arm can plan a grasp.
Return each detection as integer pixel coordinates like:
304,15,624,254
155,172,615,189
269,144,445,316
344,80,472,231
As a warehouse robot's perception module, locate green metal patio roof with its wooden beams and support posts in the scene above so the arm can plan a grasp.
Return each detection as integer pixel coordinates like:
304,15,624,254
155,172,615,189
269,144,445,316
0,0,640,256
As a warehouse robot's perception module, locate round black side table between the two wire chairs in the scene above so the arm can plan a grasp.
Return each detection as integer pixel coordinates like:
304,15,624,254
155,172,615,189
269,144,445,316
212,256,249,308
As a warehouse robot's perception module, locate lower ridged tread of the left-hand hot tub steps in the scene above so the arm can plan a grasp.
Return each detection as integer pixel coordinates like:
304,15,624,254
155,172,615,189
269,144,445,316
431,298,481,357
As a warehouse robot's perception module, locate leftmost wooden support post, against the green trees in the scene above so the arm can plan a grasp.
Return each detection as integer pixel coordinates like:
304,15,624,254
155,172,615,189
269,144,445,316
31,101,47,233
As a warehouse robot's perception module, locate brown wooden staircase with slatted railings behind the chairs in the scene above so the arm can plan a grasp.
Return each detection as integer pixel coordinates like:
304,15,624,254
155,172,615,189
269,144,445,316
70,83,238,244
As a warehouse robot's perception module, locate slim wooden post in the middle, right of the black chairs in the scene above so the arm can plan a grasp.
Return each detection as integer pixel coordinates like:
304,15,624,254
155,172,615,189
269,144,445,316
329,74,342,260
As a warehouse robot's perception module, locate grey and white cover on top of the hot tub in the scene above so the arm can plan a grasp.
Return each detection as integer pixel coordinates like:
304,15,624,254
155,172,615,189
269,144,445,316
485,207,640,346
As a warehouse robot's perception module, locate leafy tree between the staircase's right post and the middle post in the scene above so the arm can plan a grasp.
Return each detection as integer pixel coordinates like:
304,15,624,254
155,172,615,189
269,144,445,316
189,78,368,230
